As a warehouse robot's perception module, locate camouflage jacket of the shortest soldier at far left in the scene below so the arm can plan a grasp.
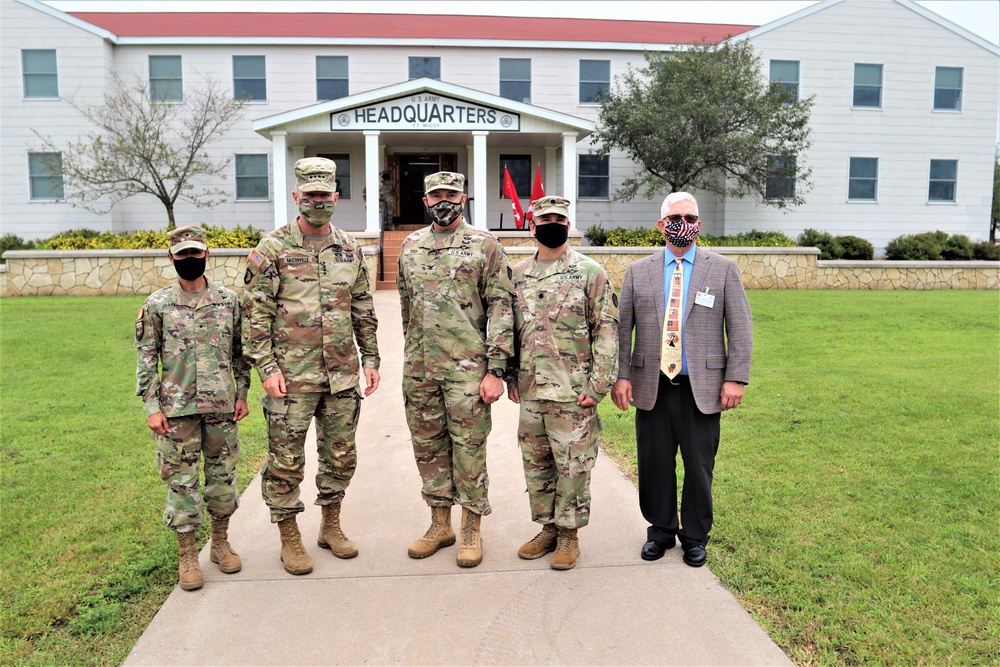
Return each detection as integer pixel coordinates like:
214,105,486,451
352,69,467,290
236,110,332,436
135,277,250,417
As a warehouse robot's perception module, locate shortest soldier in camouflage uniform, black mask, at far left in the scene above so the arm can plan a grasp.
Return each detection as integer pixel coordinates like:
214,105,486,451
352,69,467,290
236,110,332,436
135,226,250,591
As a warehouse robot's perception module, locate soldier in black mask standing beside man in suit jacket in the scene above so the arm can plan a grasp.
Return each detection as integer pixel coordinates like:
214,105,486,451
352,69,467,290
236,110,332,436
506,197,618,570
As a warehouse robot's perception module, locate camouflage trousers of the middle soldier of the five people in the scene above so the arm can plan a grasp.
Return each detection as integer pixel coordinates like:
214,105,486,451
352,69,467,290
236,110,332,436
403,376,493,515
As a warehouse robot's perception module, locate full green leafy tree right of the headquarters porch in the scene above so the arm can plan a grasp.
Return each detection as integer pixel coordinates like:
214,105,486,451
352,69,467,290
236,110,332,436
594,41,812,208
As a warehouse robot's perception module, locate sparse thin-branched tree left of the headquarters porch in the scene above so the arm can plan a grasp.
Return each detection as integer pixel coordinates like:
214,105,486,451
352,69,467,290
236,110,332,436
35,73,246,230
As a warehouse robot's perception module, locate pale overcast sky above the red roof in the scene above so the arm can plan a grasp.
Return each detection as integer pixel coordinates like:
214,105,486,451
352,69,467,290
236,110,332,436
46,0,1000,44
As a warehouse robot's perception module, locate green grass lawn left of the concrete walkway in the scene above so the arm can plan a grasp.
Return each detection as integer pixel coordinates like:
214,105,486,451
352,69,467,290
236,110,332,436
0,297,266,665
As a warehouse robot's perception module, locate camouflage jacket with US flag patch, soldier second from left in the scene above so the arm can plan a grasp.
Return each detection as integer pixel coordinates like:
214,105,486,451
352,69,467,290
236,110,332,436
243,219,379,394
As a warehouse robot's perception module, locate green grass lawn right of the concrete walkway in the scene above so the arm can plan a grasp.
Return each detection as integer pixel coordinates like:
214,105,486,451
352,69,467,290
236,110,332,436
601,291,1000,665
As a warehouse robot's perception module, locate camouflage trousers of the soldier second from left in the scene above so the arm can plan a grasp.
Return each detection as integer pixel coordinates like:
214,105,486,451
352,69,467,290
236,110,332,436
260,387,361,523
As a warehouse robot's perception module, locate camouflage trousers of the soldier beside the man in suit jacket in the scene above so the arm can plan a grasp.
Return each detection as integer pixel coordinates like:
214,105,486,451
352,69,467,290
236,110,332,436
517,399,601,528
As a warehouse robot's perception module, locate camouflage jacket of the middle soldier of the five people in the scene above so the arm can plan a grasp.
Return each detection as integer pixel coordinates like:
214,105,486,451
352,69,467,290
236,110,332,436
396,220,514,381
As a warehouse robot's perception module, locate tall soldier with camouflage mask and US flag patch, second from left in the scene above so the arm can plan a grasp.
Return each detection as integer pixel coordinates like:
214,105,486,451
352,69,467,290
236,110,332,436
243,157,379,574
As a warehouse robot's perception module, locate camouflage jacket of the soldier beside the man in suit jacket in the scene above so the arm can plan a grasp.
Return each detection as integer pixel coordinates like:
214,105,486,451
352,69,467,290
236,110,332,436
505,248,618,402
